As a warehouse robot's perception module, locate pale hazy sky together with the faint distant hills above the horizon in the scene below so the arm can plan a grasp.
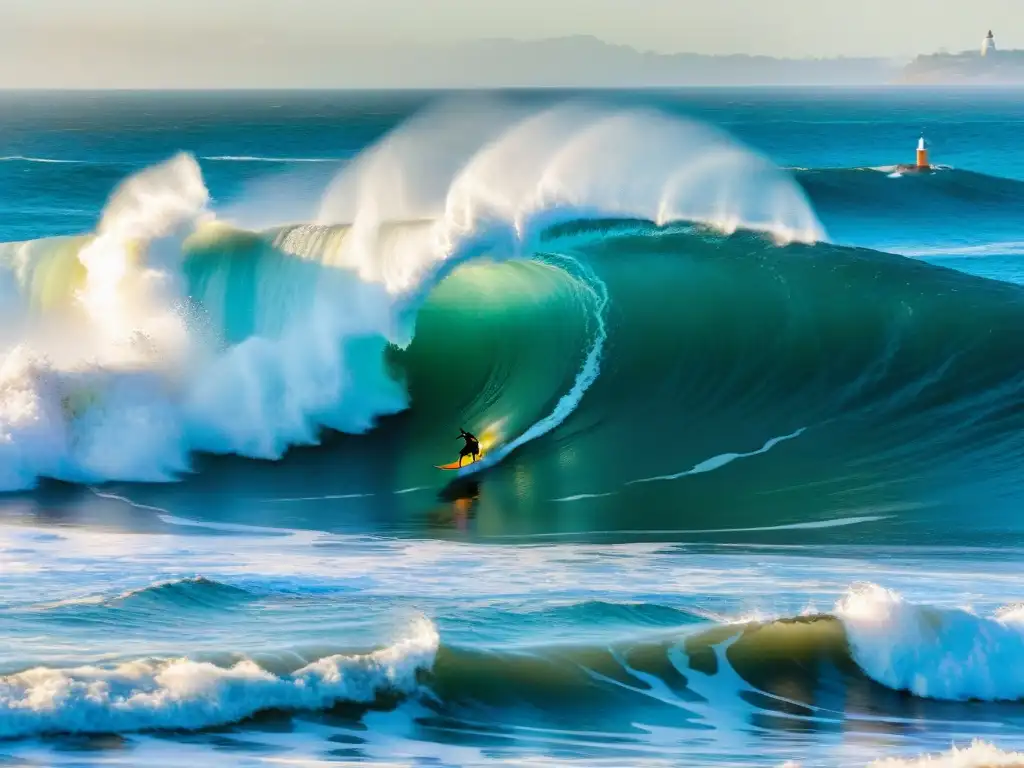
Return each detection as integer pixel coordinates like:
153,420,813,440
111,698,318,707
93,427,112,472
0,0,1024,88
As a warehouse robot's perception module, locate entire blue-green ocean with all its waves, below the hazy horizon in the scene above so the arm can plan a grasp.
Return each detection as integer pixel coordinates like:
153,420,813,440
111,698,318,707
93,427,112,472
0,88,1024,768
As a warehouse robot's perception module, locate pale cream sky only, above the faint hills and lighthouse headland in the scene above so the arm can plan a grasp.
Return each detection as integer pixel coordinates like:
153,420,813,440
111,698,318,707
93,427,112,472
0,0,1024,85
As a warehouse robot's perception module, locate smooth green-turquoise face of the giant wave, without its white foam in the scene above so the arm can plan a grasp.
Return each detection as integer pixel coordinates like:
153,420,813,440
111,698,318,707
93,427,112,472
14,214,1024,543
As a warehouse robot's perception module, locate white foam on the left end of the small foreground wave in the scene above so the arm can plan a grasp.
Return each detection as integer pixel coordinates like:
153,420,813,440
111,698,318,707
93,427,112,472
0,618,439,738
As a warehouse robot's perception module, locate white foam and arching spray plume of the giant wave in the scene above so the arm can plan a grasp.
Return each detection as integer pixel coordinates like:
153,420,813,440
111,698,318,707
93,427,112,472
0,103,823,488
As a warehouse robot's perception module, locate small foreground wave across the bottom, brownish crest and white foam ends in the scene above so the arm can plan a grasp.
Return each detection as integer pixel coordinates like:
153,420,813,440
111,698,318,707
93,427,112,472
0,585,1024,739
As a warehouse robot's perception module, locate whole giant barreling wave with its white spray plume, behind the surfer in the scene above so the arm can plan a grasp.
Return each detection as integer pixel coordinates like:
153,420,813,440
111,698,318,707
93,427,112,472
6,97,1024,541
